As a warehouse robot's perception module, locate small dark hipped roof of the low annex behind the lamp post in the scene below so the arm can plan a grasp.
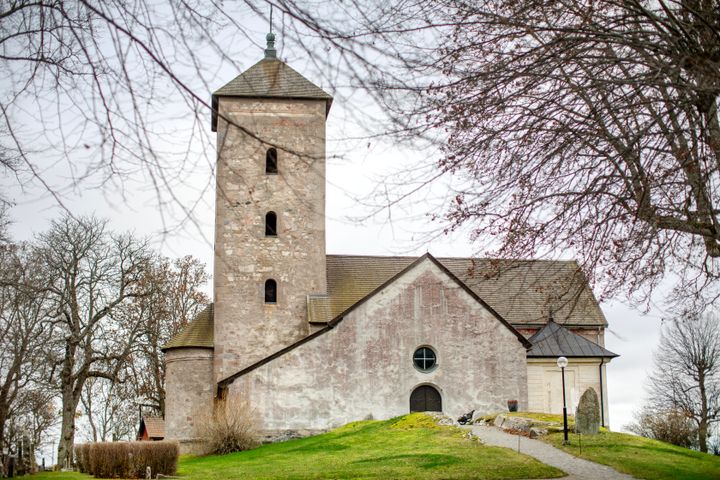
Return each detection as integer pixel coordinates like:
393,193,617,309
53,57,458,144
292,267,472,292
527,320,618,358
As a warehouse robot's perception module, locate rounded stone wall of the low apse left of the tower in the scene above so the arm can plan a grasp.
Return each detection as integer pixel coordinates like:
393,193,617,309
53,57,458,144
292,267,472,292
165,348,215,453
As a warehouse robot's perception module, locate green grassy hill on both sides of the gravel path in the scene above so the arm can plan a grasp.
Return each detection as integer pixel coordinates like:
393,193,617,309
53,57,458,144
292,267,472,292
31,414,720,480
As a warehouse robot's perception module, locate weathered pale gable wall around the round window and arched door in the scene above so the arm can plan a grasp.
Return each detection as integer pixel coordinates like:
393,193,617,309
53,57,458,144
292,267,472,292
229,260,527,435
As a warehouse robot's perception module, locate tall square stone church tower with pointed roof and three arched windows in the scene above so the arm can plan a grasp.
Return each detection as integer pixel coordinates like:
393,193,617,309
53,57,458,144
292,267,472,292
212,33,332,381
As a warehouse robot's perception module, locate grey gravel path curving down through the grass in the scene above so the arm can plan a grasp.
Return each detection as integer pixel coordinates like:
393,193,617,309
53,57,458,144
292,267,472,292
463,425,635,480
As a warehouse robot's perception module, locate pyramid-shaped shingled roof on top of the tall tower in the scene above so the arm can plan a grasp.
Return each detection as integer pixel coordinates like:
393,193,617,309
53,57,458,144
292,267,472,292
212,58,332,132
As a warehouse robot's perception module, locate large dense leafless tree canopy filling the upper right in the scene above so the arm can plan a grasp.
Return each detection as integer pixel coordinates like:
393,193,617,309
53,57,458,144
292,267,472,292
328,0,720,309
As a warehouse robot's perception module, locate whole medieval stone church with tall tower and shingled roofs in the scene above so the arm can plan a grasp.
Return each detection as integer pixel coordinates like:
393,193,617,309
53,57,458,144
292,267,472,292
164,34,616,452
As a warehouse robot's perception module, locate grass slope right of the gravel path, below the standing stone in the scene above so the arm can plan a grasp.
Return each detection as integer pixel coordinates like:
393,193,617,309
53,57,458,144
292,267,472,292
541,422,720,480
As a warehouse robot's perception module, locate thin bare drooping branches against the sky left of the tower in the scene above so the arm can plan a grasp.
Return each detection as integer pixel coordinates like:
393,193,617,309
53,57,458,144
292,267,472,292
0,0,352,229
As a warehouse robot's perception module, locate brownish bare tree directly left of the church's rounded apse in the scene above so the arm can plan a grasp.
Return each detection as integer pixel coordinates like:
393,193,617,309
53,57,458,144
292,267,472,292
81,256,209,441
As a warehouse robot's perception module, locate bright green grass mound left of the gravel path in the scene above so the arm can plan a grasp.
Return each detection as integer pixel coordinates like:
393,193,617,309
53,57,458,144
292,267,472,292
32,414,564,480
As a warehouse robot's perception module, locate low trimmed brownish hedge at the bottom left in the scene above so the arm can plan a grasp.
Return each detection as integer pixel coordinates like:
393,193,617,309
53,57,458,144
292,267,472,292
75,442,180,478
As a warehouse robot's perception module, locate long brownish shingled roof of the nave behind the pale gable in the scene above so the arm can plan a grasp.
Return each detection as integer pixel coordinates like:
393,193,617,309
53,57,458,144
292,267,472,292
308,255,607,327
